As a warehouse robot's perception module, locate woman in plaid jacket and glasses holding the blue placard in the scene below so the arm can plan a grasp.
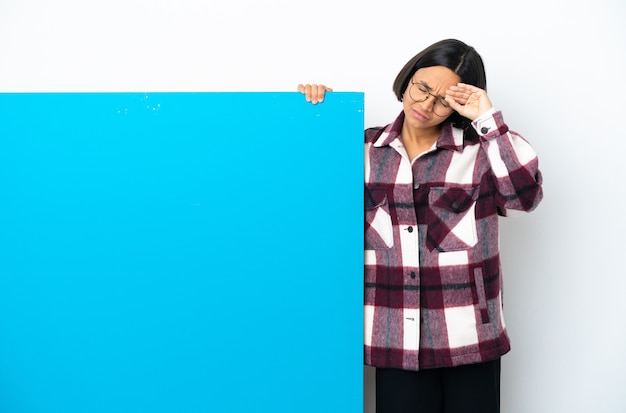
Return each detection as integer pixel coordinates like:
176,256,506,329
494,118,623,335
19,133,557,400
298,39,542,413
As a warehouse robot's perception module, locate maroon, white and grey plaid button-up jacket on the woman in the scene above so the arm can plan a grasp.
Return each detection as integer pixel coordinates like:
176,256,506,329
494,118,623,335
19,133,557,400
364,111,542,370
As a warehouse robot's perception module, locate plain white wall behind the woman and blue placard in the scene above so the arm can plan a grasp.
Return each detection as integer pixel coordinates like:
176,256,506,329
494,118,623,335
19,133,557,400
0,0,626,413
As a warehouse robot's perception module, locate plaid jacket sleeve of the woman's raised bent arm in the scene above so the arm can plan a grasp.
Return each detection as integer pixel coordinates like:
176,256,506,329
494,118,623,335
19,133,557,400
472,111,543,216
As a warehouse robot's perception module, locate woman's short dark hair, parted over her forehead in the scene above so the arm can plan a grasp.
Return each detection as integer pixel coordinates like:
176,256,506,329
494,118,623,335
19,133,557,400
393,39,487,133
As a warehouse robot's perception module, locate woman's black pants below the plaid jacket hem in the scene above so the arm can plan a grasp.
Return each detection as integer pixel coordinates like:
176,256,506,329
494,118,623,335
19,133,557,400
376,359,500,413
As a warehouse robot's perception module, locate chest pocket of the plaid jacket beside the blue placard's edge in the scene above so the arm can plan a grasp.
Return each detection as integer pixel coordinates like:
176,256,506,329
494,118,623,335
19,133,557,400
365,188,394,250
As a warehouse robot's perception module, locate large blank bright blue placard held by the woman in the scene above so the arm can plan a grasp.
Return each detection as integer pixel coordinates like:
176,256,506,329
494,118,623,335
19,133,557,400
0,93,363,413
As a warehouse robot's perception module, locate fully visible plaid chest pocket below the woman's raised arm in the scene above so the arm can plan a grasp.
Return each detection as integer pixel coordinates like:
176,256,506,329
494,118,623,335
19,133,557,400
426,187,478,252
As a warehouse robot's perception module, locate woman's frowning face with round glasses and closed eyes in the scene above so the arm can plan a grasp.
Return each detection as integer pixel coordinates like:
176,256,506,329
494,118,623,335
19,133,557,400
402,66,461,129
